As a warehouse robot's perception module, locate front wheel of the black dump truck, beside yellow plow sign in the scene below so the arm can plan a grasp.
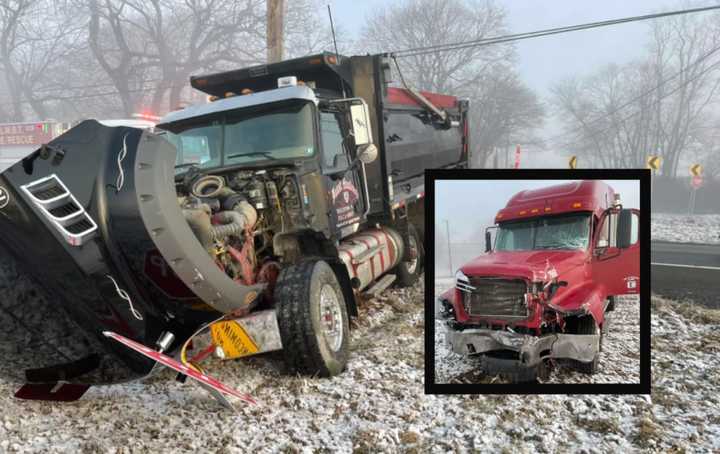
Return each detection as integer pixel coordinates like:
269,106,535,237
274,260,350,377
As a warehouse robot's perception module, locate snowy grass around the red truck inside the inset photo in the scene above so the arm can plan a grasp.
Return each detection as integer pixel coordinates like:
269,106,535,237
435,279,640,383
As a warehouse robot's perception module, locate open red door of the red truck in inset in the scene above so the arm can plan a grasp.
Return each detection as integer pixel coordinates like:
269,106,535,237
592,210,640,296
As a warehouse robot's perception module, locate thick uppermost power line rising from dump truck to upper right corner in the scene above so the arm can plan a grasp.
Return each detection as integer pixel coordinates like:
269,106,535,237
392,5,720,58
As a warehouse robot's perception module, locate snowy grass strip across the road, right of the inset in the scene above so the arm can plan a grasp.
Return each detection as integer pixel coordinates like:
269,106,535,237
651,213,720,244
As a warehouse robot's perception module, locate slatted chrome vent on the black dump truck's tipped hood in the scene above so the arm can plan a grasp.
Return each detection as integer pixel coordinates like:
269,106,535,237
21,174,97,246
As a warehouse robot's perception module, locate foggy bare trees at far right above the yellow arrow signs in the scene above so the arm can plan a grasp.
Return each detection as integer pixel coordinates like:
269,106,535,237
553,9,720,176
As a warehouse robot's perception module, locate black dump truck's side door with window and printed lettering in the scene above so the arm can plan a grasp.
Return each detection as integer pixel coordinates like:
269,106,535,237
320,112,366,238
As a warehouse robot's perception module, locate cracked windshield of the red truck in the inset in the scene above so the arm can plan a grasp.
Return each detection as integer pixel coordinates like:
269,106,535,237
495,213,590,251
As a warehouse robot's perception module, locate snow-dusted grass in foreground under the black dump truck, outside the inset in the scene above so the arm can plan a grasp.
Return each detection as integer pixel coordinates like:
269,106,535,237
0,278,720,453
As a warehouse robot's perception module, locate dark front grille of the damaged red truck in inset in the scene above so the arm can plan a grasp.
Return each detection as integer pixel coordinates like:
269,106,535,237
458,277,528,318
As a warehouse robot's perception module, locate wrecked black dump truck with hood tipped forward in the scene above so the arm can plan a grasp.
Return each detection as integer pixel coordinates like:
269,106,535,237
0,53,468,400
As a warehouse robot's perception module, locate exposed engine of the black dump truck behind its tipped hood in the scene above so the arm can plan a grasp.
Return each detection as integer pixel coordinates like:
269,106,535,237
177,169,303,285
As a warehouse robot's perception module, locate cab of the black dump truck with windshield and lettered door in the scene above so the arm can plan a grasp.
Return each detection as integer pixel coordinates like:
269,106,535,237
159,78,377,243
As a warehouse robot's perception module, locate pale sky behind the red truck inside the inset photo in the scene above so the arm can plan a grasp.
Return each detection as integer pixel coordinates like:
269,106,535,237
435,180,640,242
